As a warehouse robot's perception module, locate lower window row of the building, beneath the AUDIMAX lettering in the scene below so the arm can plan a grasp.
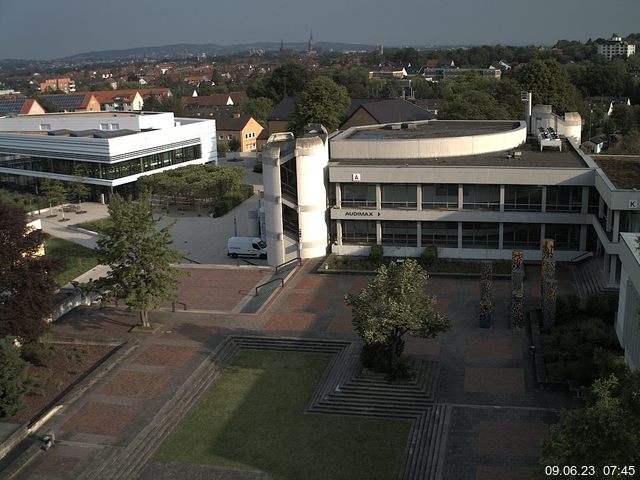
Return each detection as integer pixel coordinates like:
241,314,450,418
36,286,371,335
342,220,580,250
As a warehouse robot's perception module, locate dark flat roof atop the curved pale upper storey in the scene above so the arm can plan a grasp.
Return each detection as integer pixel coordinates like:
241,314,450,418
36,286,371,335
344,120,521,140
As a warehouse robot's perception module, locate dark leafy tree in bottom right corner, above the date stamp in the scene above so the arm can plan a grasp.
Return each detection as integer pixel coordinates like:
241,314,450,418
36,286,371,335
540,370,640,472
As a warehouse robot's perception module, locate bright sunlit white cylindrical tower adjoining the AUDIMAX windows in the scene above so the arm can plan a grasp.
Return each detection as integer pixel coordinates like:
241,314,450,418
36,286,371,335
295,136,329,258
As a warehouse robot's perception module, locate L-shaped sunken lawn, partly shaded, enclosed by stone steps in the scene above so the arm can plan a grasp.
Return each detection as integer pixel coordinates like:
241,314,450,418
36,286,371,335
155,350,411,480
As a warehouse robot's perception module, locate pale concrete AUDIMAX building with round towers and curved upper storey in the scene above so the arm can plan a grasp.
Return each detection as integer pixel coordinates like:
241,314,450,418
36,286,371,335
263,106,640,365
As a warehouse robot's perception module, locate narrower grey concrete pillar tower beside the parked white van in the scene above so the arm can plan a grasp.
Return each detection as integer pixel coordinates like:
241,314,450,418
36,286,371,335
262,146,284,266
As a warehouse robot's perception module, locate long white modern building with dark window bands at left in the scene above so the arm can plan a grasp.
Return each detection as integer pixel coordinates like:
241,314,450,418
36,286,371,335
0,112,217,199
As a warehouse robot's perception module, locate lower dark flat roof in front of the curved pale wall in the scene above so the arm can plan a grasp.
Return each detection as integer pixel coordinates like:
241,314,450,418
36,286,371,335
329,137,590,169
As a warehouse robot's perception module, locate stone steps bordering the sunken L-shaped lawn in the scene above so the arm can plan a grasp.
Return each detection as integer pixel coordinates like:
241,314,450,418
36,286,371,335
78,335,451,480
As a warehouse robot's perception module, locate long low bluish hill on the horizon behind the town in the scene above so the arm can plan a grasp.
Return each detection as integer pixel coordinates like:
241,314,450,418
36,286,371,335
61,42,377,60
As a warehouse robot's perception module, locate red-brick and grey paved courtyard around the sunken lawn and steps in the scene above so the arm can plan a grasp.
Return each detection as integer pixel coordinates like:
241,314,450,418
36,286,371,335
8,262,575,480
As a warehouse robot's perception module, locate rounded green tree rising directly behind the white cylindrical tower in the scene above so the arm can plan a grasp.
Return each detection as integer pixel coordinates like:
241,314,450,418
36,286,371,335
290,77,351,134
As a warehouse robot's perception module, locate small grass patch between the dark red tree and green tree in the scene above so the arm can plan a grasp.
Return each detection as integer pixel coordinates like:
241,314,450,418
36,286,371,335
45,237,98,287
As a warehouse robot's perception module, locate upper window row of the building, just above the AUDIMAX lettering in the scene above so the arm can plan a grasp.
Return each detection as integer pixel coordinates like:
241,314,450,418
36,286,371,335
340,184,599,213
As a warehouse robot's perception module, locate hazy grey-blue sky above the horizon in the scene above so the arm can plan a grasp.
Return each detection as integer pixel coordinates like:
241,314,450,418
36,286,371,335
0,0,640,59
